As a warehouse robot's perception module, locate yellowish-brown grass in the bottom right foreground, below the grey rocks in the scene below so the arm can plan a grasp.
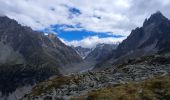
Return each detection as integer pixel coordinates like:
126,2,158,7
72,76,170,100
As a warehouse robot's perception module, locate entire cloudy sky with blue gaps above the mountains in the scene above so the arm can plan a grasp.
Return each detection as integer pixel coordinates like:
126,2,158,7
0,0,170,48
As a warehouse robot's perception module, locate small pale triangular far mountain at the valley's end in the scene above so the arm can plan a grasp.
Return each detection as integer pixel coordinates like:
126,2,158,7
72,46,93,59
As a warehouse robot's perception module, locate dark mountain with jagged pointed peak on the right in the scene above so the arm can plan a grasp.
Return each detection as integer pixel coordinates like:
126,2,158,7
100,11,170,66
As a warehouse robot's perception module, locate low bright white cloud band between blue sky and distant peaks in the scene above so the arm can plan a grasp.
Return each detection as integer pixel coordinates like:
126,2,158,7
60,36,126,48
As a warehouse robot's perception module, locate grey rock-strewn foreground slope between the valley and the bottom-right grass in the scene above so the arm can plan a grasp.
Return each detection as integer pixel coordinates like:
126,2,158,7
22,54,170,100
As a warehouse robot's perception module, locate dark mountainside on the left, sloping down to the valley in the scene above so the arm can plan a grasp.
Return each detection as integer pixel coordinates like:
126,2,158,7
0,16,82,99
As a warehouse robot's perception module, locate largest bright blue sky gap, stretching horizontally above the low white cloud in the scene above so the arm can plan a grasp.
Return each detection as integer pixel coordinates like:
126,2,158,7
40,25,125,41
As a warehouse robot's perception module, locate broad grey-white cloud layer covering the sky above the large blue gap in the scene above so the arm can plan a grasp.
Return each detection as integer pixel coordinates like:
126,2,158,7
0,0,170,36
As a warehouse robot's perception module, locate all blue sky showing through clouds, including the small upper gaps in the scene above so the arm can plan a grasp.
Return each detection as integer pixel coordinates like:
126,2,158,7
40,6,125,42
